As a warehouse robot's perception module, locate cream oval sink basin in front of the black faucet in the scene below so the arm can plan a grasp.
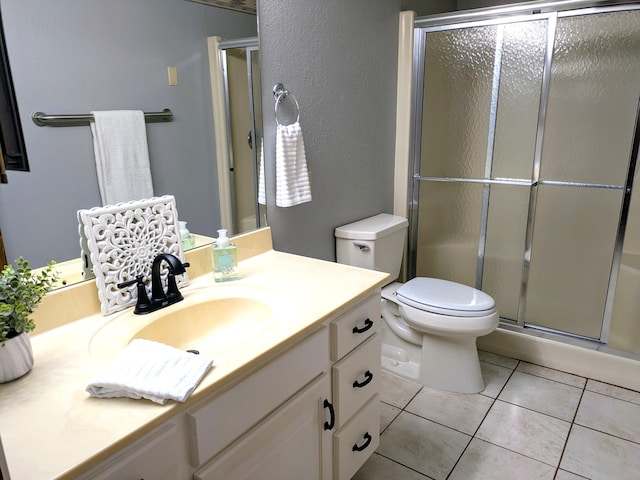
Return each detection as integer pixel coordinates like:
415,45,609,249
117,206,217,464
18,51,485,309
89,287,274,358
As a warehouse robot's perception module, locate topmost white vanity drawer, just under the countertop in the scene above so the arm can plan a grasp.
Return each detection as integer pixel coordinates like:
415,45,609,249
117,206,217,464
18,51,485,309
331,290,381,362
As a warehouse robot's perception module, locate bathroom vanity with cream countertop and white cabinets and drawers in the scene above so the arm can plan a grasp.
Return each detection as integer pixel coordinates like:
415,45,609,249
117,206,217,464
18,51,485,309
0,229,387,480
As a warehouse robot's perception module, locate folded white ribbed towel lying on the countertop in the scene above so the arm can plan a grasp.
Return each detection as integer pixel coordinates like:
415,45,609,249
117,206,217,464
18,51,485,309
86,339,213,404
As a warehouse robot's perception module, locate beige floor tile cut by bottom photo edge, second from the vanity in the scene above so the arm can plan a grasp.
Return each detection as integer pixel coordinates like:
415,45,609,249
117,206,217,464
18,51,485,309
449,438,555,480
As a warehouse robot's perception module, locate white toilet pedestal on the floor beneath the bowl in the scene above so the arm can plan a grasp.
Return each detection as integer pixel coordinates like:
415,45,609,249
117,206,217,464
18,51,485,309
418,335,484,393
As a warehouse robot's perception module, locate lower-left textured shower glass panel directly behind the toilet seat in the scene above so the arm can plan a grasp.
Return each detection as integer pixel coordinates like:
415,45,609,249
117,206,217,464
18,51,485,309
416,181,482,287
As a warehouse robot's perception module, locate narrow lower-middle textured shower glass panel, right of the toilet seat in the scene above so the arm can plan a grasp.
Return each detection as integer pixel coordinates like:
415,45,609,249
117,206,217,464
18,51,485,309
482,185,530,320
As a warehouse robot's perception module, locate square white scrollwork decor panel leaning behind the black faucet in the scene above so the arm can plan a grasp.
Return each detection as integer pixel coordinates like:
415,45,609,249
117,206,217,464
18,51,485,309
78,195,189,315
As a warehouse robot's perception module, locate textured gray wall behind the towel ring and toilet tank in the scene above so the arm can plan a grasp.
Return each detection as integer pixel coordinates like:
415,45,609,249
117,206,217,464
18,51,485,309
258,0,400,260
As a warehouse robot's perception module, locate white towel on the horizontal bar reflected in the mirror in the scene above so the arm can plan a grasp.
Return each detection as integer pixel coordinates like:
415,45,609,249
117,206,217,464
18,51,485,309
91,110,153,205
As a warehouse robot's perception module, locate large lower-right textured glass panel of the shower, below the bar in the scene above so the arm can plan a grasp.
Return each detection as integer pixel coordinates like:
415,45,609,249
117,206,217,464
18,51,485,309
525,185,622,338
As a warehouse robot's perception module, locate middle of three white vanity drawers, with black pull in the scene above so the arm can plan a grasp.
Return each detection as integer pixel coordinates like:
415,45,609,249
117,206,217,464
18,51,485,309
332,333,381,427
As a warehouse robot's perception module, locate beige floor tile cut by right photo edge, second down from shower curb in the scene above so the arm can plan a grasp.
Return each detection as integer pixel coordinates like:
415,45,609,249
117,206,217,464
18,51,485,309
575,391,640,443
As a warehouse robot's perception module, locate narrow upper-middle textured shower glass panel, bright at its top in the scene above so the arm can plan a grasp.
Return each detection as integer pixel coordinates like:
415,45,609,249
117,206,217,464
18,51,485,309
491,20,547,179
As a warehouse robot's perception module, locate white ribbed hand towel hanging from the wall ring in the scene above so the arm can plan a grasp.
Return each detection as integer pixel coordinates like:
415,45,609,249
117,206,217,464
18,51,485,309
276,122,311,207
